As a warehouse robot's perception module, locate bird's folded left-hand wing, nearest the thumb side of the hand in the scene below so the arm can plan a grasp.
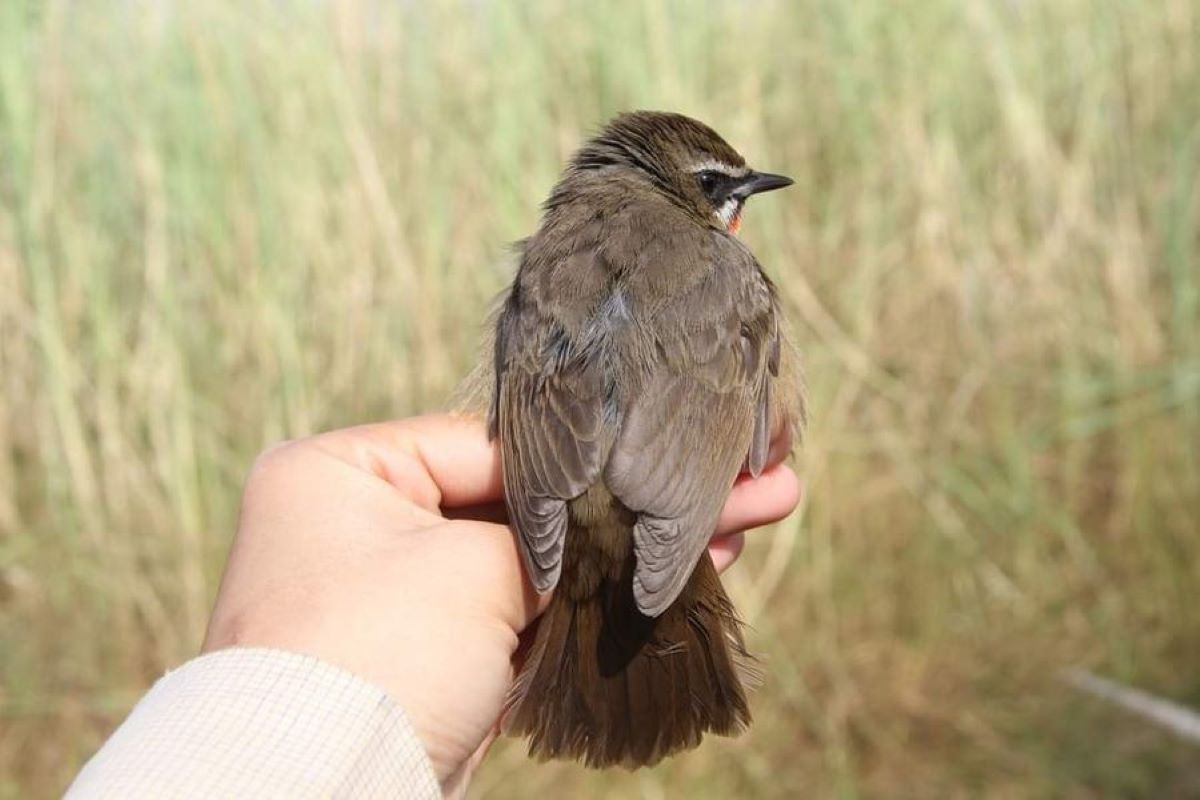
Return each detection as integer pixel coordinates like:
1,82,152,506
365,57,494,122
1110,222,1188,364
490,266,606,591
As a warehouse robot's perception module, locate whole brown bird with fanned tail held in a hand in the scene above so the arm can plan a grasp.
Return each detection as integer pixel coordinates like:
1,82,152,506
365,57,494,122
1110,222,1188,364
488,112,800,766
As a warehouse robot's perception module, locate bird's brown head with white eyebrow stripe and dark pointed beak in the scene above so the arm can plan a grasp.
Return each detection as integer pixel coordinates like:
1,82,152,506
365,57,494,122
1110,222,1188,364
571,112,792,233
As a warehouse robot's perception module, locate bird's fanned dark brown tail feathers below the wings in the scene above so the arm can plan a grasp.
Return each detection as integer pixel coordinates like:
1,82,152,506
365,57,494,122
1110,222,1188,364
503,553,756,768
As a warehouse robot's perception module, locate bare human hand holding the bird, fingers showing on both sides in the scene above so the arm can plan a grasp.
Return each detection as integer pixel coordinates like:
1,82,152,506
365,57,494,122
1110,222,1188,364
204,415,799,789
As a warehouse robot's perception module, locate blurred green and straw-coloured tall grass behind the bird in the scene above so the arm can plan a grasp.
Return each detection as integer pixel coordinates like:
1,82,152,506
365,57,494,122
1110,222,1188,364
0,0,1200,798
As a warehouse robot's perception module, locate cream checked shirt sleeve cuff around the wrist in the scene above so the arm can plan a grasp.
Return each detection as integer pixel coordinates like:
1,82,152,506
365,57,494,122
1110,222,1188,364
66,648,442,800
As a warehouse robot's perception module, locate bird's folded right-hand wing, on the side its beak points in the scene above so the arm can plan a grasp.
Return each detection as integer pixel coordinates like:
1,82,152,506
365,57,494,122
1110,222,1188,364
605,234,780,616
